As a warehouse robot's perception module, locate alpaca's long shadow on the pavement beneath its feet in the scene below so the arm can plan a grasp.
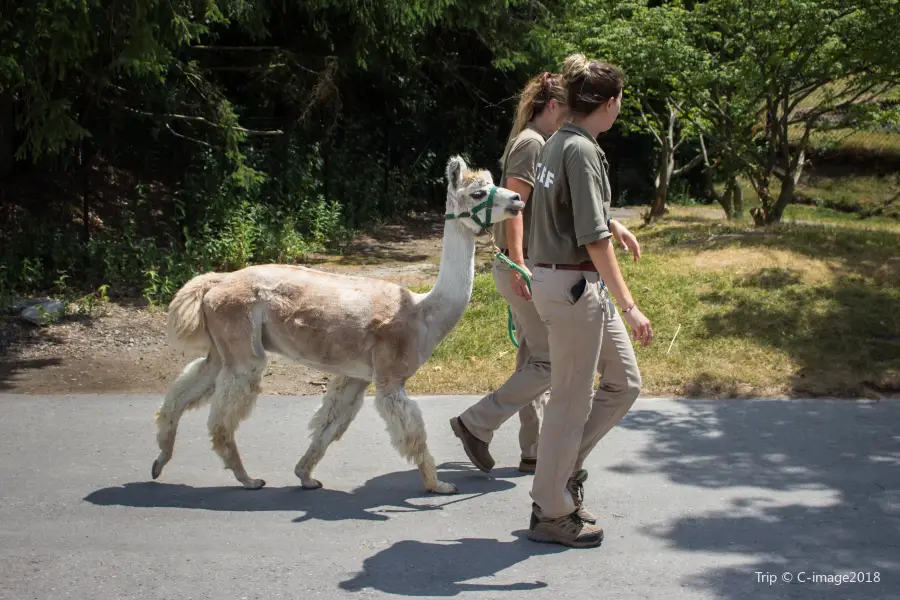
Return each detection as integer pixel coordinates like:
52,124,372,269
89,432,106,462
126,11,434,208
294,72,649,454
84,463,515,523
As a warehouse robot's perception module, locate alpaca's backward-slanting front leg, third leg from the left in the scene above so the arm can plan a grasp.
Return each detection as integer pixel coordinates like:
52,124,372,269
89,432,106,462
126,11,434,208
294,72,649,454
294,376,369,489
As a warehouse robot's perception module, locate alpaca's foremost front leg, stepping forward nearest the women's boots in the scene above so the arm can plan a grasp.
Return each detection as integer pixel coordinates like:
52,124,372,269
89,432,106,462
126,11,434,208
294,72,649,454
375,383,456,494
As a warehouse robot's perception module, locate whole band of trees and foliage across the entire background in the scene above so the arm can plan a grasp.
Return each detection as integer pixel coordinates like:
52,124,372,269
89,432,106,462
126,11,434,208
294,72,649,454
0,0,900,302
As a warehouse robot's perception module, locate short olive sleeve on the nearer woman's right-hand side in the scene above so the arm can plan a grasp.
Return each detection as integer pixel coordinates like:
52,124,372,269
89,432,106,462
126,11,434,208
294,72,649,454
564,143,612,246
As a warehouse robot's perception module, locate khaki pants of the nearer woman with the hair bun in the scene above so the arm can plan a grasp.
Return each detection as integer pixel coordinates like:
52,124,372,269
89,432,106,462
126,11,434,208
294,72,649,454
531,267,641,519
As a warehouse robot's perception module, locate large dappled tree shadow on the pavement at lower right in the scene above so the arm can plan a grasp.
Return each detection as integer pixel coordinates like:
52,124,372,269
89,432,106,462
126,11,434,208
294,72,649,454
610,400,900,600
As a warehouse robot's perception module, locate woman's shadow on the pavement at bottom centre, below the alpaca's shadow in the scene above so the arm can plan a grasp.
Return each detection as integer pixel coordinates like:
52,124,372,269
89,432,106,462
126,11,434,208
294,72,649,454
338,532,564,597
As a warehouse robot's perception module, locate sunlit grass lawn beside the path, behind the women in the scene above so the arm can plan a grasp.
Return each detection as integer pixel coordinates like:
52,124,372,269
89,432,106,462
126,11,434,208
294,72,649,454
408,207,900,397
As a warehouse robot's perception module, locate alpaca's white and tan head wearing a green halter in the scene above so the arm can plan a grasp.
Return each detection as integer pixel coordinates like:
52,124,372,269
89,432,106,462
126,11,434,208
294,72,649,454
447,156,525,232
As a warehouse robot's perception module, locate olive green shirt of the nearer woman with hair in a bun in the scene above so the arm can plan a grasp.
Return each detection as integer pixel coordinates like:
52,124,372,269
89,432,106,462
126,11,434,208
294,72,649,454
528,123,612,264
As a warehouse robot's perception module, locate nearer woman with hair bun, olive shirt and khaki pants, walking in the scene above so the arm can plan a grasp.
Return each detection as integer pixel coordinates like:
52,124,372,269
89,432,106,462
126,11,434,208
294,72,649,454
528,54,653,547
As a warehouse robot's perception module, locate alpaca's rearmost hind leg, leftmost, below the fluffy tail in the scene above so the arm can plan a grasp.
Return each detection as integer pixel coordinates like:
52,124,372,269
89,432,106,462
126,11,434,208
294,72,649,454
150,355,221,479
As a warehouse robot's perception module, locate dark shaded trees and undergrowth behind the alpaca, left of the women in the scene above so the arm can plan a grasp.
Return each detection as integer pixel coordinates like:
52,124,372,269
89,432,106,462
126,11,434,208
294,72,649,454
0,0,563,302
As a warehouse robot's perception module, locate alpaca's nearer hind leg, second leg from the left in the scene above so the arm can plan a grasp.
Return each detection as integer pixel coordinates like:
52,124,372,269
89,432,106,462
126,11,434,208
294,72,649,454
207,362,266,490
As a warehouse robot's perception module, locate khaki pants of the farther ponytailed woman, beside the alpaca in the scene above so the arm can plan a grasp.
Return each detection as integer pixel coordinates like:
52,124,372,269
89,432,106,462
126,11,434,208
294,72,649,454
460,258,550,458
